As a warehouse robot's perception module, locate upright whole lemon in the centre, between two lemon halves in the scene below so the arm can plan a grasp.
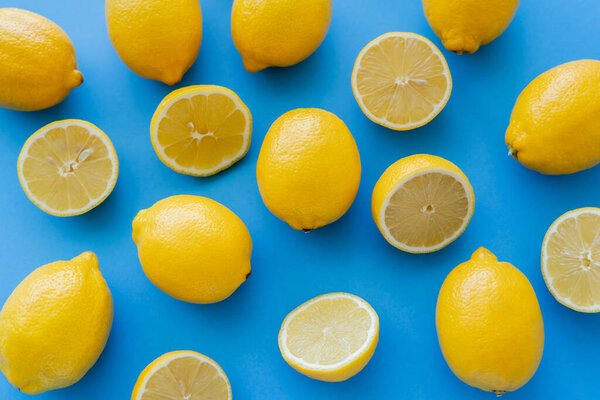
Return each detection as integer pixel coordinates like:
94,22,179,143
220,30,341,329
256,108,361,230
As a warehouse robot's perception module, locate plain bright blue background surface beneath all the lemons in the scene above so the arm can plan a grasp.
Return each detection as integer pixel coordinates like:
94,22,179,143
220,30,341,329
0,0,600,400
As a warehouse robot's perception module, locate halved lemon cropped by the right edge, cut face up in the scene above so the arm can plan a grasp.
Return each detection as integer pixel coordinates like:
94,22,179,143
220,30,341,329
542,207,600,313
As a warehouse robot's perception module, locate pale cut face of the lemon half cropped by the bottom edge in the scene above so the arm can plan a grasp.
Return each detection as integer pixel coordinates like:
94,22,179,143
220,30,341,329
138,356,230,400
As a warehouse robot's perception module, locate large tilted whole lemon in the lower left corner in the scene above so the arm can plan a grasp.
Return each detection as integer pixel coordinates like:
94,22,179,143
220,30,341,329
0,251,113,394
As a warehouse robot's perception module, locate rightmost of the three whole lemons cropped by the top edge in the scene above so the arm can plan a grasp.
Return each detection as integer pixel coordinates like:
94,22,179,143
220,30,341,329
423,0,519,54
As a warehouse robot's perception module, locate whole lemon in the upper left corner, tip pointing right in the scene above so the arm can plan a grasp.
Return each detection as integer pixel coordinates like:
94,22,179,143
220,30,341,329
0,8,83,111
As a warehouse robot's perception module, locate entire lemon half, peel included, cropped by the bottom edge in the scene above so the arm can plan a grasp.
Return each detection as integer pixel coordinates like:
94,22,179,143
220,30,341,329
131,351,231,400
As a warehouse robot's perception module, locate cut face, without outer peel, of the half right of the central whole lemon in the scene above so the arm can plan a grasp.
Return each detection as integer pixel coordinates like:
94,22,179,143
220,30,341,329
384,172,469,248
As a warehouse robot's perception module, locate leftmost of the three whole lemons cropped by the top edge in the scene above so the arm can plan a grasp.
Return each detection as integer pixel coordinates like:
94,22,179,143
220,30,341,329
105,0,202,85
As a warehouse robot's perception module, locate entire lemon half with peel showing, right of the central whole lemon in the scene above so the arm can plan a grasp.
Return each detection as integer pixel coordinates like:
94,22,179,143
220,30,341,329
371,154,475,253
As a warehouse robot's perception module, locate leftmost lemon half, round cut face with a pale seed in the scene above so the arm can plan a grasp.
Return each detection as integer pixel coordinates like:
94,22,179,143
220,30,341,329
17,119,119,217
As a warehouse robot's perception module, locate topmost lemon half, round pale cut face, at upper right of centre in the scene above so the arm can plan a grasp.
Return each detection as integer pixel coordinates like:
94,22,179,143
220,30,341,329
352,32,452,131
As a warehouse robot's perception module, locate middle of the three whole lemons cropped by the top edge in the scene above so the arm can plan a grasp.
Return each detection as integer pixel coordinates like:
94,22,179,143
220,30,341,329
231,0,332,72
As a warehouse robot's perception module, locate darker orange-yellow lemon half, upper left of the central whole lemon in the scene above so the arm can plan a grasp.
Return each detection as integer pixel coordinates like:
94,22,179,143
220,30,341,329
150,85,252,176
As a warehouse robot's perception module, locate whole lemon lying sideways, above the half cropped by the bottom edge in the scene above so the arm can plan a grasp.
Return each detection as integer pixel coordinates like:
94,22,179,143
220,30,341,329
133,195,252,304
